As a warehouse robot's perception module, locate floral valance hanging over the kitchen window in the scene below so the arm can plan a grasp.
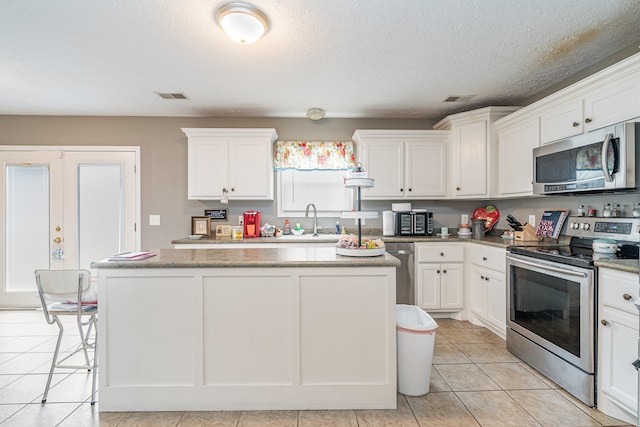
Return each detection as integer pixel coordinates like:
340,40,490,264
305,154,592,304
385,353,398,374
273,141,356,170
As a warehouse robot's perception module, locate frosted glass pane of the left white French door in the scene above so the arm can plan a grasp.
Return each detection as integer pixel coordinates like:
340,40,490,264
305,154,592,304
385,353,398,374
5,165,50,292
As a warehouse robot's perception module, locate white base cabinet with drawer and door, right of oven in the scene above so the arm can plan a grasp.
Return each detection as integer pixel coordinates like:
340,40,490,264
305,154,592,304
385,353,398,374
597,268,640,425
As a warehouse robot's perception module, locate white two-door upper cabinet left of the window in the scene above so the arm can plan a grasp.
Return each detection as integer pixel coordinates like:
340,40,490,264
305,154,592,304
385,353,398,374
182,128,278,200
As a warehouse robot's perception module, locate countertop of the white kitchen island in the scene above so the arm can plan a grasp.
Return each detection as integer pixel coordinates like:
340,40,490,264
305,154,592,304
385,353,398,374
91,246,400,269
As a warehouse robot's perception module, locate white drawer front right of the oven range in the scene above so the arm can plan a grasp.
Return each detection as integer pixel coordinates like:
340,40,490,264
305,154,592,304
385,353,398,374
598,269,640,315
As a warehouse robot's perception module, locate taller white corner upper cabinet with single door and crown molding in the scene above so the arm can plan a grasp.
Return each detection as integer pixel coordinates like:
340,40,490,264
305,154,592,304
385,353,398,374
434,107,519,198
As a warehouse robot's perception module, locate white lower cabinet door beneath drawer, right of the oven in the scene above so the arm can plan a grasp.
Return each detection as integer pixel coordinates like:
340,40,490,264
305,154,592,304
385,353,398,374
598,306,638,414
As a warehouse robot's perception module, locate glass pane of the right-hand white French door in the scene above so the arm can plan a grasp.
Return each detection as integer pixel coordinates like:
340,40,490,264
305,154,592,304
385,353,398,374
77,163,124,269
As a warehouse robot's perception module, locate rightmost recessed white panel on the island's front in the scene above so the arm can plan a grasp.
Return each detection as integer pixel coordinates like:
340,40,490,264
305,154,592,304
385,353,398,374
300,276,390,386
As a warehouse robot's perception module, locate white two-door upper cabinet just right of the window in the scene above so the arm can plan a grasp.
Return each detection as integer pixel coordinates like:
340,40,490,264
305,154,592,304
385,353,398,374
353,130,449,200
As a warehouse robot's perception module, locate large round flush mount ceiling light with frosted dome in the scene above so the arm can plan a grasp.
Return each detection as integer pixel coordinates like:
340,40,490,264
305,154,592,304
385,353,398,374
216,2,269,44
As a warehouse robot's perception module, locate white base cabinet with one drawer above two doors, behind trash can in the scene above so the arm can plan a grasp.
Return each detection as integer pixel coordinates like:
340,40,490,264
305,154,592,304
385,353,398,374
414,243,464,311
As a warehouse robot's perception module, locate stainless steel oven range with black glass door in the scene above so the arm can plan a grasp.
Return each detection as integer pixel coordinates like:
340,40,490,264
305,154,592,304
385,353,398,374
507,217,640,406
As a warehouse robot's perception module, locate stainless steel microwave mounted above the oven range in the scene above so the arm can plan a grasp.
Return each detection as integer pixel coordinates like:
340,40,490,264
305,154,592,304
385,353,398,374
533,122,640,194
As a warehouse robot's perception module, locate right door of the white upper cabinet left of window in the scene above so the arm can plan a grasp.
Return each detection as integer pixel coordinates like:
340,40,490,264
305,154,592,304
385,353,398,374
228,137,273,200
